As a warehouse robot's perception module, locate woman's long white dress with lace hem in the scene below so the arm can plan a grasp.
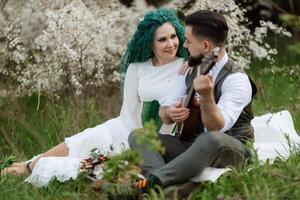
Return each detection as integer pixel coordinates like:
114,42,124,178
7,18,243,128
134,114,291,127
25,58,184,187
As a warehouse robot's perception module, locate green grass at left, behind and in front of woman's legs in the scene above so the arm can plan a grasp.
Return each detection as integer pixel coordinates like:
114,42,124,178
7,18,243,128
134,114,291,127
0,93,120,200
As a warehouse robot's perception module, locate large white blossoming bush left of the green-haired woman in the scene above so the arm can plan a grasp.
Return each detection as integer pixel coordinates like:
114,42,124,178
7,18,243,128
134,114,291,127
0,0,149,96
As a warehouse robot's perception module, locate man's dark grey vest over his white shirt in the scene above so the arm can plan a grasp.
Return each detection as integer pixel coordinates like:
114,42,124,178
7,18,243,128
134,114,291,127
186,59,257,143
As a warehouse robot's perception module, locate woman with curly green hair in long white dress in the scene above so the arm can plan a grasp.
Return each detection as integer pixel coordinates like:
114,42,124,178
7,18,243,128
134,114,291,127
2,9,187,186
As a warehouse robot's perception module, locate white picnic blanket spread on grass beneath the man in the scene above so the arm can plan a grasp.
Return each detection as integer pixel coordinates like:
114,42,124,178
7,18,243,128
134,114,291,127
191,110,300,182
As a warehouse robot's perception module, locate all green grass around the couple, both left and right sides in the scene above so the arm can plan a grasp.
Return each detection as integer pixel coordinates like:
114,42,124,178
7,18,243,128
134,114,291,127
0,44,300,200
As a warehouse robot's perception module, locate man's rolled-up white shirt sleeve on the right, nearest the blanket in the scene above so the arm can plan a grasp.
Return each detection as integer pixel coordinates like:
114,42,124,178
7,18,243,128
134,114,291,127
217,72,252,132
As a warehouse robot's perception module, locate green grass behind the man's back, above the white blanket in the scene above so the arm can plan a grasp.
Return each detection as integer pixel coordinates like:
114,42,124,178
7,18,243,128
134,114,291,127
247,43,300,133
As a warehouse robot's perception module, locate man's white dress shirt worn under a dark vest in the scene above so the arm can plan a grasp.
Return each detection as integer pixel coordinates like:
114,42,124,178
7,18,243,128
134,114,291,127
164,53,252,132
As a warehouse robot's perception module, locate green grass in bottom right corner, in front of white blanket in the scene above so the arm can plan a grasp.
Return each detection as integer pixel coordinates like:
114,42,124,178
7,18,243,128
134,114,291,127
191,152,300,200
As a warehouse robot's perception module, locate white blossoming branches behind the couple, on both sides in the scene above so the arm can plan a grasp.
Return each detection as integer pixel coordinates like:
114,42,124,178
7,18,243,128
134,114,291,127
0,0,289,97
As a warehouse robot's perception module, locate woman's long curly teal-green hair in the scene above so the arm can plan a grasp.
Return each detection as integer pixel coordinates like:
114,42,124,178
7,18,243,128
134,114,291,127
120,8,187,88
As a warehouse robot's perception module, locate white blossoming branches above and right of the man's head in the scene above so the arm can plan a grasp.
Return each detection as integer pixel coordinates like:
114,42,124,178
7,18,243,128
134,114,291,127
166,0,290,68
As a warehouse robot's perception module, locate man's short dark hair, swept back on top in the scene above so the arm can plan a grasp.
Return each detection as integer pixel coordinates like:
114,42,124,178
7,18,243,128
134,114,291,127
185,10,228,46
